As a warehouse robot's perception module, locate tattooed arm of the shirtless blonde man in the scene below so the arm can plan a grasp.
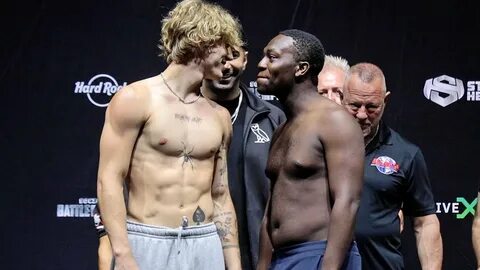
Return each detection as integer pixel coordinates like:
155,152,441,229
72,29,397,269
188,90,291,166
212,110,242,270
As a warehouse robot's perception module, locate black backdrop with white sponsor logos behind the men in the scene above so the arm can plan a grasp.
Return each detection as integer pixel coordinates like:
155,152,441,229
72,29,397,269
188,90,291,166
0,0,480,270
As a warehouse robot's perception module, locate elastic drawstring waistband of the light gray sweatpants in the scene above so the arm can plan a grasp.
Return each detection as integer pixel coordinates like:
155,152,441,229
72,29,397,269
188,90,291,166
127,220,217,237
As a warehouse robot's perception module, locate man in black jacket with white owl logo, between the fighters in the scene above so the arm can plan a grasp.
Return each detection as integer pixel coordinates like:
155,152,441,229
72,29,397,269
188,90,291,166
202,44,285,269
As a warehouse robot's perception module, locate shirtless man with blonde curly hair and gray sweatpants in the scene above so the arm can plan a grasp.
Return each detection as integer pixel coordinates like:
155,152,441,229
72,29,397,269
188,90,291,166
97,0,242,270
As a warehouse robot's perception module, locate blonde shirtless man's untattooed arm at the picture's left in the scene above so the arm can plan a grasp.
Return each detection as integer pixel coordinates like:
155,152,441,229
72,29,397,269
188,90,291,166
97,86,147,269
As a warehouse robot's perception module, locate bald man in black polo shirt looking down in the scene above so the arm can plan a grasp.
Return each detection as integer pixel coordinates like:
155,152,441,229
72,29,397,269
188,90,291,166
343,63,442,270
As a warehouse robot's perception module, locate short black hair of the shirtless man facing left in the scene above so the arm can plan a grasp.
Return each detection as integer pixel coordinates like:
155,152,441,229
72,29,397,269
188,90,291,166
280,29,325,84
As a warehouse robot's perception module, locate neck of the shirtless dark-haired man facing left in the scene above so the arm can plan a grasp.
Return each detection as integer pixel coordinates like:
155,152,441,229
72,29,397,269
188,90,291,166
279,80,318,118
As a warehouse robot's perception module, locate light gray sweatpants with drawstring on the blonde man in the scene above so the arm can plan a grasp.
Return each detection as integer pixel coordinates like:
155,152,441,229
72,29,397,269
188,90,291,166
113,221,225,270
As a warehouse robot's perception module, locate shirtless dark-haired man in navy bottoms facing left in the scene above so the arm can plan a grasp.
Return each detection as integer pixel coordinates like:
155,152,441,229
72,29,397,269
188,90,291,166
257,30,364,270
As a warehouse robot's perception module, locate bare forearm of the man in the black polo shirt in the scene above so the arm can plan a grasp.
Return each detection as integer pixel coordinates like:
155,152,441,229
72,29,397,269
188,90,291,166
413,214,443,270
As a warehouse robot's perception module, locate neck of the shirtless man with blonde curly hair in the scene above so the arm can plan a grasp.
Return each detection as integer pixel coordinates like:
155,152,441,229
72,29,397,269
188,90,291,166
162,61,203,99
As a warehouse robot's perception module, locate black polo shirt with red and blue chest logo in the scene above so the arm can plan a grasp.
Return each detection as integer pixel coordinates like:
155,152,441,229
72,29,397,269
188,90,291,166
355,123,435,270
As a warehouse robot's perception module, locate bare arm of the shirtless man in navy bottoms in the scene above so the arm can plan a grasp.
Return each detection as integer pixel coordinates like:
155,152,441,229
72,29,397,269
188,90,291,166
321,111,365,270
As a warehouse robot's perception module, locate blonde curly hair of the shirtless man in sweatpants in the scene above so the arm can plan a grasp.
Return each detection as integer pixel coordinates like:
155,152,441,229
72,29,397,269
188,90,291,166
159,0,243,64
